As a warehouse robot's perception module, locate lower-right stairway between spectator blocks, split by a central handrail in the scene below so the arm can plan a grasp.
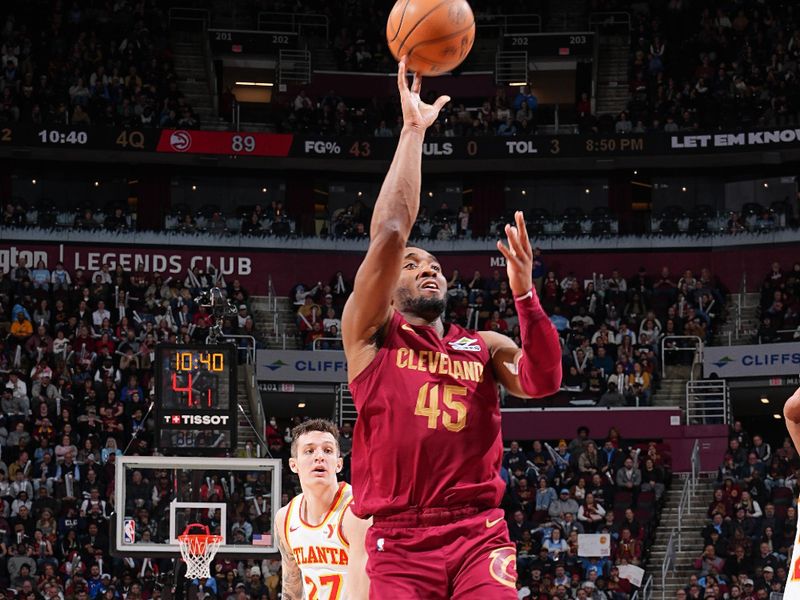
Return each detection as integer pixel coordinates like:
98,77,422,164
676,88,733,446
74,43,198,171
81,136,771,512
647,473,715,598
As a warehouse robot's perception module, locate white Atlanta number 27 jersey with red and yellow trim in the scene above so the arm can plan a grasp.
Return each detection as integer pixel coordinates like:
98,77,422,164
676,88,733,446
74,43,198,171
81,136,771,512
283,483,353,600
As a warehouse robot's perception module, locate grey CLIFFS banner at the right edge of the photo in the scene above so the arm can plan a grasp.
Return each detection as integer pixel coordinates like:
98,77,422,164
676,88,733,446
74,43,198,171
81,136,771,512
703,343,800,379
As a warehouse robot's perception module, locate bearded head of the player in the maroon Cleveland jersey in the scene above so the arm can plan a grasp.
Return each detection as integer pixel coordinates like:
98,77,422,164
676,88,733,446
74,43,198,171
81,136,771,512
394,248,447,321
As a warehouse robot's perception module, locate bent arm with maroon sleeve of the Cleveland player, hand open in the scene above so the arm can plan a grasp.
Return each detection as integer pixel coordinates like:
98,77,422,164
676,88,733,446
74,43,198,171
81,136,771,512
481,211,561,398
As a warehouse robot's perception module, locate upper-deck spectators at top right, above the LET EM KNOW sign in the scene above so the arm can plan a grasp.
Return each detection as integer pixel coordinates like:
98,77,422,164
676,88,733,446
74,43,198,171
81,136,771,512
589,0,800,133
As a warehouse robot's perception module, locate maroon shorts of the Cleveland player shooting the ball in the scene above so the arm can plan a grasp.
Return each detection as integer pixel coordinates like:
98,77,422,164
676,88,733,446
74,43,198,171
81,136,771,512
366,508,517,600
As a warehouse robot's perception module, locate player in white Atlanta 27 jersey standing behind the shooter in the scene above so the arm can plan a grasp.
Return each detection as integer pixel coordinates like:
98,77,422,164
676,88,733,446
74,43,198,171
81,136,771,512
275,419,369,600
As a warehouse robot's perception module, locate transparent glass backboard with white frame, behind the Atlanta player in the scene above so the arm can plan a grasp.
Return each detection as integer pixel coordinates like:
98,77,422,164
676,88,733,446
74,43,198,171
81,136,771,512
112,456,281,558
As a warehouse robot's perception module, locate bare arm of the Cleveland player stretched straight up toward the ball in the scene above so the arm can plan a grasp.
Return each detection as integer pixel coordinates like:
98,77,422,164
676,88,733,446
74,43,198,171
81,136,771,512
342,60,450,381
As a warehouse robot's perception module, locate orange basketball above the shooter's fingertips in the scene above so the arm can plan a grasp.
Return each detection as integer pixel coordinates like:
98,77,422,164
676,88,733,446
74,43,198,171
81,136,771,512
386,0,475,77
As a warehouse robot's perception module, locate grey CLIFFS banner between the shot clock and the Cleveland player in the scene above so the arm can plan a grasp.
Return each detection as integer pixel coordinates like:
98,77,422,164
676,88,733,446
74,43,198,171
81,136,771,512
256,350,347,383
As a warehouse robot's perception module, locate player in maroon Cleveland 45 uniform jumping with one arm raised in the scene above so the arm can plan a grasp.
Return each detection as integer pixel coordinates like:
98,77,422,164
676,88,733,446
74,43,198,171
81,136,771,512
342,60,561,600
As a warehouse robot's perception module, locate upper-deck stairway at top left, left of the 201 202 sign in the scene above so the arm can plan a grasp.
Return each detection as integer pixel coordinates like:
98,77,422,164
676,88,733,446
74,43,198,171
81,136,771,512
171,31,230,131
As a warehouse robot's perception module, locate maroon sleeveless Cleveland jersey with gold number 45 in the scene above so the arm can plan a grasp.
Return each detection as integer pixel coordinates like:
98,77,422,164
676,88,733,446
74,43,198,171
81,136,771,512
350,312,505,517
